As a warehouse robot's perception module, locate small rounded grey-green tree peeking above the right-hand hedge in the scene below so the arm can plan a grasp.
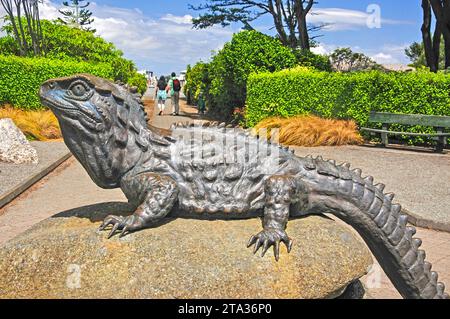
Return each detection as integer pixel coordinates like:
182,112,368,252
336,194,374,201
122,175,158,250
330,48,382,72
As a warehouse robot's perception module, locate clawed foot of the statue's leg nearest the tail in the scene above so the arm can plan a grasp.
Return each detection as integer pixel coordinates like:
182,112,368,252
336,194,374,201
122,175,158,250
247,228,293,261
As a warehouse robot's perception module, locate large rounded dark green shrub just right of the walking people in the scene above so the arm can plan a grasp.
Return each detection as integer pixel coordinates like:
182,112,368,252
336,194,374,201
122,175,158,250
188,31,297,121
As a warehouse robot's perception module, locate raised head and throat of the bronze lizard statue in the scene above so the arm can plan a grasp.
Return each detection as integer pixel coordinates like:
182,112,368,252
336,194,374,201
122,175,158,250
39,74,147,188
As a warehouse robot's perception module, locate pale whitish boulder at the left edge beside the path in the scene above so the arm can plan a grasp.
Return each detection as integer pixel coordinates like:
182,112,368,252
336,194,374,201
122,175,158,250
0,119,38,164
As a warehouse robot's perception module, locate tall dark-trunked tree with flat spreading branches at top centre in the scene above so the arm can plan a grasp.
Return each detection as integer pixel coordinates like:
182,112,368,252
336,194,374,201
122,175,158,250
189,0,321,50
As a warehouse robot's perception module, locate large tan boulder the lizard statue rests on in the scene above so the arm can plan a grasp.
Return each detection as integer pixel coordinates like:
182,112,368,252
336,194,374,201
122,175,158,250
0,203,372,299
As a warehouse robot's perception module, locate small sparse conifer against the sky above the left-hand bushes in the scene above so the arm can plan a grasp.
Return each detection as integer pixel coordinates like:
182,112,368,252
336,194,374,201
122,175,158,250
58,0,96,33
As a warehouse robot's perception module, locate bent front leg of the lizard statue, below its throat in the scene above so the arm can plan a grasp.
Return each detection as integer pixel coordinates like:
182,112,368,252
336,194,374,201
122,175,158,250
100,173,178,238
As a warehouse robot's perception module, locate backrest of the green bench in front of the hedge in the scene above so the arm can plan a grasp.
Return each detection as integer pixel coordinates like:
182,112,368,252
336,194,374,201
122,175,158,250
369,112,450,128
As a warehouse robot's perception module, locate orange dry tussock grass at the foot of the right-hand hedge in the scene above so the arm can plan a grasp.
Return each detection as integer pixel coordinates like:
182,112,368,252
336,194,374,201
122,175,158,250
254,115,364,147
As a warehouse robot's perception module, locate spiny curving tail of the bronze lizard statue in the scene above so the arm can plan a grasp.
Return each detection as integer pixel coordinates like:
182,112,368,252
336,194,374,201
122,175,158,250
302,157,449,299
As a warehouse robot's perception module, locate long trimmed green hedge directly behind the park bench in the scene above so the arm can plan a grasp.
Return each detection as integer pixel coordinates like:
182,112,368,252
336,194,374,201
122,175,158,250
245,68,450,140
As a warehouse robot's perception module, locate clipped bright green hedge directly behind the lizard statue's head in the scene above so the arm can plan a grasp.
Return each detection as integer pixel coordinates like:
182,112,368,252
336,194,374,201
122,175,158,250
0,55,114,109
